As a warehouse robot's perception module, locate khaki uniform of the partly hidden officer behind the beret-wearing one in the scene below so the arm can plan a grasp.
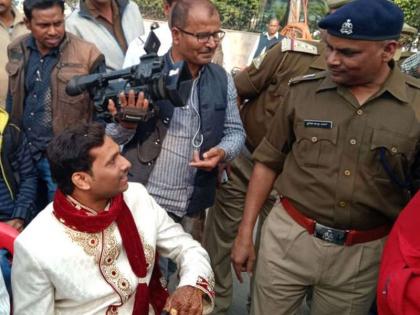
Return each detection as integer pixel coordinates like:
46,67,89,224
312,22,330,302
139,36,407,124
204,38,326,314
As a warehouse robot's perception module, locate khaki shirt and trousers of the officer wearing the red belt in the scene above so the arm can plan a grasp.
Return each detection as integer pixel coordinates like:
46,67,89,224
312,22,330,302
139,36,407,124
251,63,420,315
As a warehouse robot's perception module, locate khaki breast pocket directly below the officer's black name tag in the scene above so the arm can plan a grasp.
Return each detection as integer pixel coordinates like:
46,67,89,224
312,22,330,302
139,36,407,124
293,122,338,168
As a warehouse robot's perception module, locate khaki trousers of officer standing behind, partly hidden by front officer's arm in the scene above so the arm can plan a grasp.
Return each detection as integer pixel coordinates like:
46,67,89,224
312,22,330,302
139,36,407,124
203,152,275,314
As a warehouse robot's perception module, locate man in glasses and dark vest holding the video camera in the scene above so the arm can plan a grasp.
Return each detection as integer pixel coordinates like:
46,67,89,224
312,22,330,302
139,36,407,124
108,0,245,246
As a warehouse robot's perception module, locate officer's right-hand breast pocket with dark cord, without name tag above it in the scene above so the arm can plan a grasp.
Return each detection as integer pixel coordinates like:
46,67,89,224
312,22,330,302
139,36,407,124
368,129,416,182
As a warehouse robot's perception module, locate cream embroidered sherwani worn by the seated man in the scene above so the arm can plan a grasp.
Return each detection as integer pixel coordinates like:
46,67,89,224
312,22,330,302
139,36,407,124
12,183,214,315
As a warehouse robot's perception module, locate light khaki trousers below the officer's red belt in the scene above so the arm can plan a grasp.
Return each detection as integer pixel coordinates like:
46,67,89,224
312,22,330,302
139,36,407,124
251,204,386,315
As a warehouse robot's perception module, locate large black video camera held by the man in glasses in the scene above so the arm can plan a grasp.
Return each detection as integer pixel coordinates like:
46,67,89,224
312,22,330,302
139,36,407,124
66,26,192,122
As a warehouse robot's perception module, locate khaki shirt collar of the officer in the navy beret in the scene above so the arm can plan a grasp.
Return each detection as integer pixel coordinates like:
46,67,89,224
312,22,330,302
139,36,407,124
317,60,408,103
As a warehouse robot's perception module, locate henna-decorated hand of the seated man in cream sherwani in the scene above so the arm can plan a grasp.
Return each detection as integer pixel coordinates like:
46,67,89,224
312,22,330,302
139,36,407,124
164,285,203,315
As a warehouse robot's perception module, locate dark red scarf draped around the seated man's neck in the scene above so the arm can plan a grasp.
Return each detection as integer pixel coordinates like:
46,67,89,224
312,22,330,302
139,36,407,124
53,190,168,315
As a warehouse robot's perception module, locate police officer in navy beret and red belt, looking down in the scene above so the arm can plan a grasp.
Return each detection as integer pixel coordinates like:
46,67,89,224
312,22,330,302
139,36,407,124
233,0,420,315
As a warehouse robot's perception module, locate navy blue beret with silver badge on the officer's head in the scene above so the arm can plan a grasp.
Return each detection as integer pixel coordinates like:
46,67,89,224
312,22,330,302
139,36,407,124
318,0,404,40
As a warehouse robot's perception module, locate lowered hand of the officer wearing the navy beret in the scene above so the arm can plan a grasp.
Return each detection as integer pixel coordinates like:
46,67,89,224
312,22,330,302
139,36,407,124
230,233,255,283
